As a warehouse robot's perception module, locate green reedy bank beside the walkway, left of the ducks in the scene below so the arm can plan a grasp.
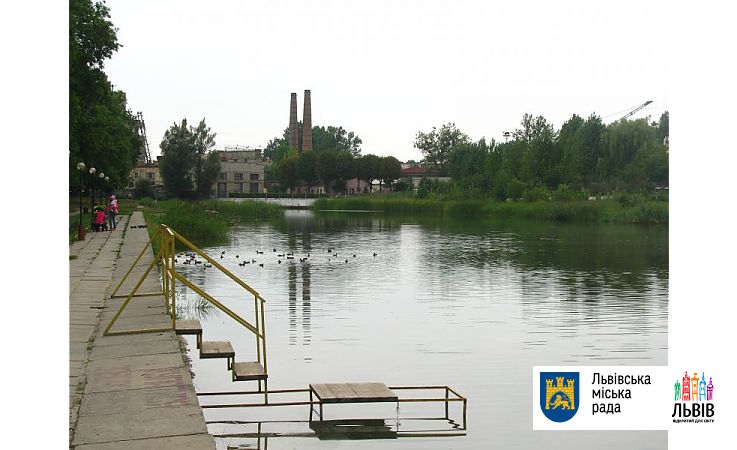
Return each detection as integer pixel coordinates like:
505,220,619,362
140,199,284,246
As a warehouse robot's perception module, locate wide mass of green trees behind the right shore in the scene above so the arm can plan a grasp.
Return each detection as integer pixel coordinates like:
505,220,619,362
415,111,669,199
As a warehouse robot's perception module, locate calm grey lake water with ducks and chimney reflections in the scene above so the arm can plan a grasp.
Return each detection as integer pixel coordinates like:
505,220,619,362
174,211,668,449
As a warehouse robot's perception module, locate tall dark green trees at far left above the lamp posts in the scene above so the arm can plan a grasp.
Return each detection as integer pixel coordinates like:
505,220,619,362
69,0,141,192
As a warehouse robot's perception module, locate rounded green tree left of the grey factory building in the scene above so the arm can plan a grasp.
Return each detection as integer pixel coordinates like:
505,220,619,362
159,118,220,199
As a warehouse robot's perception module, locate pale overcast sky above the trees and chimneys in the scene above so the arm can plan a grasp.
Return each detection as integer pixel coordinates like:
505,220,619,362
106,0,668,161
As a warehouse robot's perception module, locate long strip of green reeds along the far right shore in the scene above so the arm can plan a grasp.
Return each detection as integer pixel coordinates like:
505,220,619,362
313,196,668,225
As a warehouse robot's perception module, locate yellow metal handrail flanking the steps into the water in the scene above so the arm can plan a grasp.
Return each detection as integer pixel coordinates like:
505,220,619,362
103,224,268,373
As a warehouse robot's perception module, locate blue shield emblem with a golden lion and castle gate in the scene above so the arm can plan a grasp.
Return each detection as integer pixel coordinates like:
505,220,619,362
540,372,579,422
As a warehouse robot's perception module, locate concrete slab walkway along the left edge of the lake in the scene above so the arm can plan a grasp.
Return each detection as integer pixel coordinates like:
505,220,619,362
69,212,215,450
